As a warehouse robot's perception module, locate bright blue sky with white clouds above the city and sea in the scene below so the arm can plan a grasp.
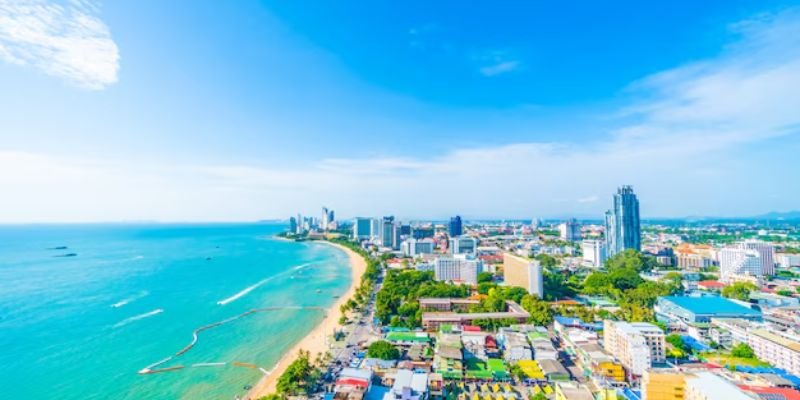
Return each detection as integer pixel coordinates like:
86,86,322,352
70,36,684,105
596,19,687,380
0,0,800,222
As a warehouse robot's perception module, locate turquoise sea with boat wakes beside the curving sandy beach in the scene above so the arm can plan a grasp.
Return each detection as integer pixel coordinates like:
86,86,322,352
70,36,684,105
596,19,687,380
0,224,350,400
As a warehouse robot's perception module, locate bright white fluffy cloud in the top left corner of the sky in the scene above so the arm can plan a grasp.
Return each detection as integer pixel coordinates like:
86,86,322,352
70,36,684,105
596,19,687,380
0,0,119,90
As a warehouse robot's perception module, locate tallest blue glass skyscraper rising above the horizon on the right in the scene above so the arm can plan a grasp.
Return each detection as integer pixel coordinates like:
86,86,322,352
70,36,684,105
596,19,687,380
605,186,642,257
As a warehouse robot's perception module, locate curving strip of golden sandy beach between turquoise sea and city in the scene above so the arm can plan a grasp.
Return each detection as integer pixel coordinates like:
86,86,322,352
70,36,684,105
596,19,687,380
247,241,367,400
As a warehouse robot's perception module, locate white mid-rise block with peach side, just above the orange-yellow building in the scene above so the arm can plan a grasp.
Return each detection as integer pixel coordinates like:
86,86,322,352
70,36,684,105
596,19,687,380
603,320,666,376
